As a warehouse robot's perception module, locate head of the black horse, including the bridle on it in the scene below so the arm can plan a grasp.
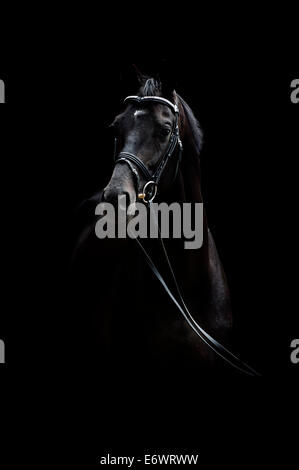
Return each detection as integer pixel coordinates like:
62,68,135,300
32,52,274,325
103,77,190,211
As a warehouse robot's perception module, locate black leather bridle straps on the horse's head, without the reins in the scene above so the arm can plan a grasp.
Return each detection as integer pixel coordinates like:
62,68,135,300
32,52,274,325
114,95,183,203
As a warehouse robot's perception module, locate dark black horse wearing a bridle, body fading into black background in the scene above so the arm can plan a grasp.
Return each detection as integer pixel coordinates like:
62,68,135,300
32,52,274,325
73,77,236,368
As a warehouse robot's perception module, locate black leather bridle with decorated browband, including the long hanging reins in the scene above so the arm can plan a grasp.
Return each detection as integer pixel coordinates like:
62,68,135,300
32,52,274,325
108,95,260,375
